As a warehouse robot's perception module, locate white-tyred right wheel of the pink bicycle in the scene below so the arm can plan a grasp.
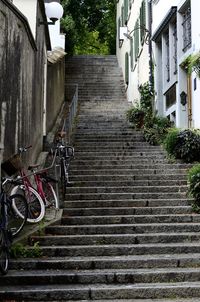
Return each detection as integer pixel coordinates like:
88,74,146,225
42,179,59,209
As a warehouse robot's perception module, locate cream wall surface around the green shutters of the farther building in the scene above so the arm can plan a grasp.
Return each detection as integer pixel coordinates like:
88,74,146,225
116,0,150,102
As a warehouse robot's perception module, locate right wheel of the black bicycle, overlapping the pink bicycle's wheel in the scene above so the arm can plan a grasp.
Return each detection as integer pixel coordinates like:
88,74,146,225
8,194,28,238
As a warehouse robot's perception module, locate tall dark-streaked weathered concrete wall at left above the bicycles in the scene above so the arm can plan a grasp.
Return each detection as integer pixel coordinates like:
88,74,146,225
0,1,46,165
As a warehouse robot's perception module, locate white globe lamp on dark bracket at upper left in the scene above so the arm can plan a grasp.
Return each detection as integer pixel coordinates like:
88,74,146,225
39,2,64,25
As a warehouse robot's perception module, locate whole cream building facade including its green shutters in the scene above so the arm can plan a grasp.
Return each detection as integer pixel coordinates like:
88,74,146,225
116,0,150,103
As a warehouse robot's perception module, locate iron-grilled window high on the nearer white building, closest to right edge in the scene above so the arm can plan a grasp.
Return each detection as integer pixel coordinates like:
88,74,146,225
182,7,192,52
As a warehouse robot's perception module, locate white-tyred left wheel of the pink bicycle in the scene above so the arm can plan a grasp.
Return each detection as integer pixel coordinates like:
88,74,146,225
11,185,45,223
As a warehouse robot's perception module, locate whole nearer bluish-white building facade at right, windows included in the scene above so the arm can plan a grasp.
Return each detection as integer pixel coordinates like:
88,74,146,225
152,0,200,128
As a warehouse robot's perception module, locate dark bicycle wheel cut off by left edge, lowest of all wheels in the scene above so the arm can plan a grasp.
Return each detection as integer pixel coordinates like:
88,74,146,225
0,229,9,275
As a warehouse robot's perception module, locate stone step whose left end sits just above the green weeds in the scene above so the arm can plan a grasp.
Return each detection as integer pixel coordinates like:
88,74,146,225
31,232,200,246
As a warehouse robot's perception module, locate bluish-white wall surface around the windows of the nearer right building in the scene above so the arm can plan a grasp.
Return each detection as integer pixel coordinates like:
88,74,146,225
152,0,200,128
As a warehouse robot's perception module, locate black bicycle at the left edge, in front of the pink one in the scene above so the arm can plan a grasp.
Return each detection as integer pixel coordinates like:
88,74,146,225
0,178,28,275
